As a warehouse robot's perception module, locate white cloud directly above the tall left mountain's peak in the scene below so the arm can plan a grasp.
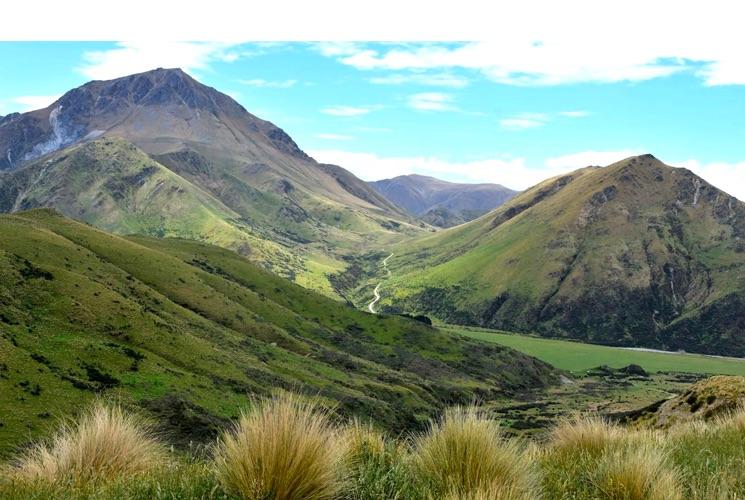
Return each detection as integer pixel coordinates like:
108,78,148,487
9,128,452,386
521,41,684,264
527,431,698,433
77,42,240,80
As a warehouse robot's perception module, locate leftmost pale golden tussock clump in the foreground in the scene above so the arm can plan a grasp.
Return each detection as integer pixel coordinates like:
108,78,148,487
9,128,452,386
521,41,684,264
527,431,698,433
13,402,167,483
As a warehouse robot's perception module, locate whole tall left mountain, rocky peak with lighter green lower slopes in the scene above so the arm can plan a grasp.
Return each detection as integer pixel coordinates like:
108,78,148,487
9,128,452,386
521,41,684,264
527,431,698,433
0,69,420,295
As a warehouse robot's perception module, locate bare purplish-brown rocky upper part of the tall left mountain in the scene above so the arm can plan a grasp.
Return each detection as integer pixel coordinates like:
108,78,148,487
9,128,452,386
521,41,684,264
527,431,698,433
0,68,310,171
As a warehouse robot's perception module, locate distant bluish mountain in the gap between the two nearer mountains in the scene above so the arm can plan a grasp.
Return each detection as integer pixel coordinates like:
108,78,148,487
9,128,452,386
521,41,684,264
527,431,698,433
369,174,517,227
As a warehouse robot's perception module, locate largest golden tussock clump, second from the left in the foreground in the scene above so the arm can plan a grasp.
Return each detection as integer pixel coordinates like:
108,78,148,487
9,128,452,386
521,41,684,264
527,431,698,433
215,395,344,500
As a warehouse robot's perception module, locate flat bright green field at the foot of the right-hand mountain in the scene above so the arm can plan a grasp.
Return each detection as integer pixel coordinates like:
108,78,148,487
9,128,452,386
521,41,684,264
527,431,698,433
442,325,745,375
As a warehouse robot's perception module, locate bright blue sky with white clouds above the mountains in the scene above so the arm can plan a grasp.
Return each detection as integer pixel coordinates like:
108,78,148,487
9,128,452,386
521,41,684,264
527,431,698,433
0,39,745,200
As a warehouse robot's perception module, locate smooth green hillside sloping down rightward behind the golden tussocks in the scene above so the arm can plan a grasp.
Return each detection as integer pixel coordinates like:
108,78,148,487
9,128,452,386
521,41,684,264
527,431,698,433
0,208,558,455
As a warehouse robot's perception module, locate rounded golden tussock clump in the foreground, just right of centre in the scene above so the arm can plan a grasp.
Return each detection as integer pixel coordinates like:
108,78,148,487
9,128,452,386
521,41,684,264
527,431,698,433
414,407,537,499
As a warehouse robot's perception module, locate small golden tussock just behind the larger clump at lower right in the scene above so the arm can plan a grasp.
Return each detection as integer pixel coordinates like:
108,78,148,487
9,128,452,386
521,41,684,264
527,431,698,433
549,416,626,455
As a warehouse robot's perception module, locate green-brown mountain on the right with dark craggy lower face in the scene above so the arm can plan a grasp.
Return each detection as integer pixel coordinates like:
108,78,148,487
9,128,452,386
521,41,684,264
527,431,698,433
374,155,745,356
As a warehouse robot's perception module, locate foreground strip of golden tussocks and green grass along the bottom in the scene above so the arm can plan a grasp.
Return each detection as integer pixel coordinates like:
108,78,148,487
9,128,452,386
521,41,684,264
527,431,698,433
0,395,745,500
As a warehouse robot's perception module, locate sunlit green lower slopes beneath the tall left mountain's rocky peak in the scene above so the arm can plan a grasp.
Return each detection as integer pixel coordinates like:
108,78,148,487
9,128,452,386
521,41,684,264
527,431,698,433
0,137,416,296
